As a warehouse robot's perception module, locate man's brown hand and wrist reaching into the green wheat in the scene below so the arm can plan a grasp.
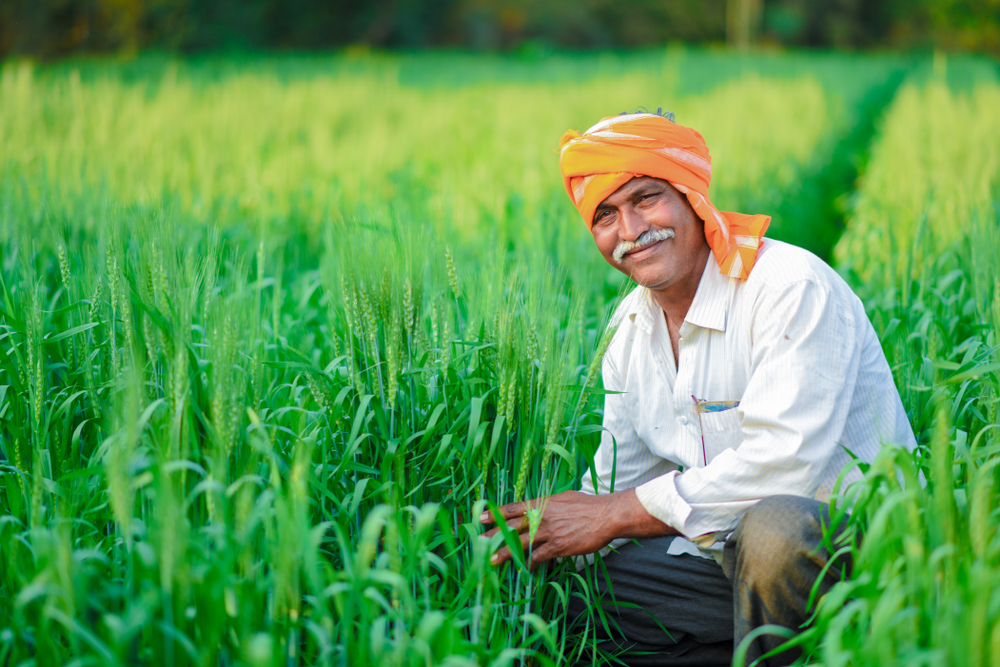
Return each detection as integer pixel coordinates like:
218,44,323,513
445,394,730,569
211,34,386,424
479,489,678,569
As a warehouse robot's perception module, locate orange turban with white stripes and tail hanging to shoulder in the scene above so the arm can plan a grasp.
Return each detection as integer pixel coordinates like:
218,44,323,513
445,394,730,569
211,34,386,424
559,113,771,280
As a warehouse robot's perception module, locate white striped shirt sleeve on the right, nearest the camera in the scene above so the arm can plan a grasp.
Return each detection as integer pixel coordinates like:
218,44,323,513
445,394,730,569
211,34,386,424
637,280,860,546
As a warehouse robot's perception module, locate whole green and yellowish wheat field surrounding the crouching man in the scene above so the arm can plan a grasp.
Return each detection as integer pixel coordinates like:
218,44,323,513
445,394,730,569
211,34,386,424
0,48,1000,667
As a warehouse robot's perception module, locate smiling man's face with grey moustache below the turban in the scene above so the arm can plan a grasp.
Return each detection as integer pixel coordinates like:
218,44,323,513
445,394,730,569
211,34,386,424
591,176,709,291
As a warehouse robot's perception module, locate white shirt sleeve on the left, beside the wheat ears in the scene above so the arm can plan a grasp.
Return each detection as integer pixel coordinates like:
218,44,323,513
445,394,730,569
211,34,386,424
580,325,676,495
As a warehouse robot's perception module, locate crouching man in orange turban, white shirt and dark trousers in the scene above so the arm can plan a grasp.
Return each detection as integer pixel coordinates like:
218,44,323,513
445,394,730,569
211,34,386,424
481,113,914,665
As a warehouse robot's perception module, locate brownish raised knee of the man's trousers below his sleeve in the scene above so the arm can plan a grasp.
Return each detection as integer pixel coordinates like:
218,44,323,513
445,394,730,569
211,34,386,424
725,496,827,586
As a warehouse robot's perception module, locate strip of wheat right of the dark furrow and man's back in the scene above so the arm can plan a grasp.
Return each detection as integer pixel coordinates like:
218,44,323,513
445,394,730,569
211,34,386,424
811,69,1000,667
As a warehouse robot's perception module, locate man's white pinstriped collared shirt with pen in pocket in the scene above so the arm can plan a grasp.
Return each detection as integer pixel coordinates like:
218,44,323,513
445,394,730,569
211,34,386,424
583,239,915,556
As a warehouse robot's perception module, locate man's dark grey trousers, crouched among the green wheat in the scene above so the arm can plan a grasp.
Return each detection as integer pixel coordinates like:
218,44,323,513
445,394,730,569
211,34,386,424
570,496,849,667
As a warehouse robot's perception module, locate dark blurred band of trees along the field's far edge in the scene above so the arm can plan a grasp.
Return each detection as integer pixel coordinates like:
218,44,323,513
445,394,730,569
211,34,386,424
0,0,1000,59
